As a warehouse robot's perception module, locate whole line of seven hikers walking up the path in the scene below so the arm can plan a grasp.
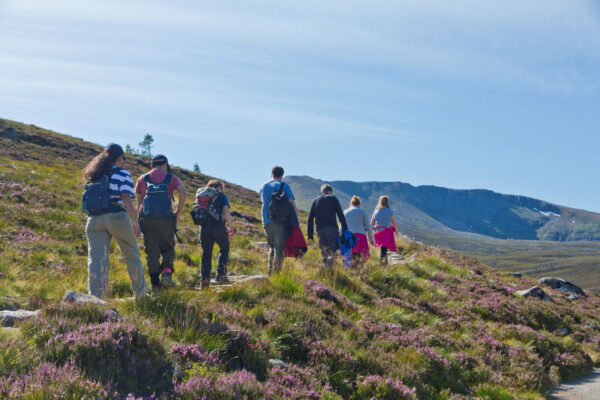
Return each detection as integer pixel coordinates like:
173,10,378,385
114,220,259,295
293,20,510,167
82,143,398,298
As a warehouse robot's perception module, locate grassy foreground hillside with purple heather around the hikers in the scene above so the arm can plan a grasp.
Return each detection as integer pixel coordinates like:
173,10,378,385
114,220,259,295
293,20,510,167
0,117,600,399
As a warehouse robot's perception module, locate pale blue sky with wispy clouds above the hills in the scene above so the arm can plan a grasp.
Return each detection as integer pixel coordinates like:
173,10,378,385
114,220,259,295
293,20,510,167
0,0,600,211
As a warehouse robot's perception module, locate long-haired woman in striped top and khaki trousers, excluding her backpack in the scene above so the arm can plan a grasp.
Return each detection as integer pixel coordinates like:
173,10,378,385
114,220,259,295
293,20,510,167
83,143,146,298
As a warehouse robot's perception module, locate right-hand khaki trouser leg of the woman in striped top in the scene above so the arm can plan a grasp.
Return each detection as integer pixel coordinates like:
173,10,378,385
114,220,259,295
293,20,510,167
109,212,147,299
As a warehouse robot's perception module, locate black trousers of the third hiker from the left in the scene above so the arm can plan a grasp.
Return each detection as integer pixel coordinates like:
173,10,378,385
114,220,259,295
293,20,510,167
200,222,229,279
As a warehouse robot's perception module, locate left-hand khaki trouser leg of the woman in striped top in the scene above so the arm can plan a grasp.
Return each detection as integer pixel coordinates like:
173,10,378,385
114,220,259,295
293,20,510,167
85,215,111,299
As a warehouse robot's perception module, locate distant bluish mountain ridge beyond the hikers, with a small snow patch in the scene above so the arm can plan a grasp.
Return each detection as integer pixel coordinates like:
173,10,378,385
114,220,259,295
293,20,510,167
285,176,600,242
